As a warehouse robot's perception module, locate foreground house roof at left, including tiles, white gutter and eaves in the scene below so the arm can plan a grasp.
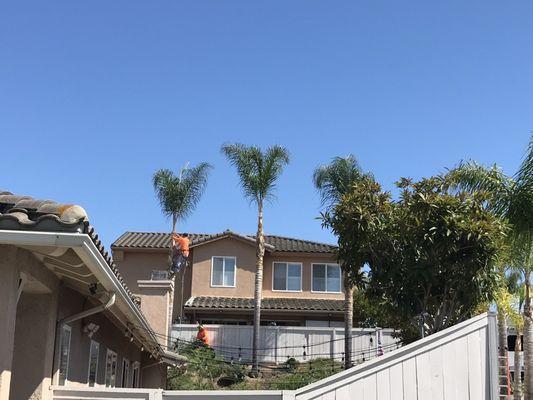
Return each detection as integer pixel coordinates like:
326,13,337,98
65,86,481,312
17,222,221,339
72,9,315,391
0,190,167,357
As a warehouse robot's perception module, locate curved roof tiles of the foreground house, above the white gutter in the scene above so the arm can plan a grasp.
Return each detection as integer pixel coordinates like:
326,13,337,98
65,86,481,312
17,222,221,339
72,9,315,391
0,190,139,305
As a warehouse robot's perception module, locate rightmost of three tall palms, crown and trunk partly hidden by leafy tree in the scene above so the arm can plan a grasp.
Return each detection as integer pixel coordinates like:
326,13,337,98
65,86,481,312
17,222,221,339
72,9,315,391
313,154,369,368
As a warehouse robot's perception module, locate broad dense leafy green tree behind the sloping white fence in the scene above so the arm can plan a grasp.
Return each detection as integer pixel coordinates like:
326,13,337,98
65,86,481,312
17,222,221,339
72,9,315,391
331,177,505,341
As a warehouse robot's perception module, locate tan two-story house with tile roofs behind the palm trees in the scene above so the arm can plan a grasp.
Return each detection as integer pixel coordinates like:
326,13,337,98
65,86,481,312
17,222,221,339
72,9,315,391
111,231,344,326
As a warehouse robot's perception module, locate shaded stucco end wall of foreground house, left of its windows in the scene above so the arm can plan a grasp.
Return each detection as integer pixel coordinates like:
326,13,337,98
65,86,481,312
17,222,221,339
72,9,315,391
0,245,59,400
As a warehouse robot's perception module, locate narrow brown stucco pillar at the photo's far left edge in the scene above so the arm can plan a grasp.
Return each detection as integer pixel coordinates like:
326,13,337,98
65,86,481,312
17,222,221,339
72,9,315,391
0,245,20,400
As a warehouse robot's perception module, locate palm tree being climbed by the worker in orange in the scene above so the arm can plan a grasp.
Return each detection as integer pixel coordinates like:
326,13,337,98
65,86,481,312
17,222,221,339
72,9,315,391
152,162,212,322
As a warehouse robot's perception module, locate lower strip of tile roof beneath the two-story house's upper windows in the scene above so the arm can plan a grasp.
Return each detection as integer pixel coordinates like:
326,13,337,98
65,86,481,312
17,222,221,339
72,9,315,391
184,296,344,312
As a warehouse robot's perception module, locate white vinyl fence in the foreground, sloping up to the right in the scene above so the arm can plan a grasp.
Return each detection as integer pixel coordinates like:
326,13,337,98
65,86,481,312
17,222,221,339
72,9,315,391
52,314,498,400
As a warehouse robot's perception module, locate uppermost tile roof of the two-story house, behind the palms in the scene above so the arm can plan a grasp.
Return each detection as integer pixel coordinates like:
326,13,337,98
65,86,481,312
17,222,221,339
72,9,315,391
111,231,337,253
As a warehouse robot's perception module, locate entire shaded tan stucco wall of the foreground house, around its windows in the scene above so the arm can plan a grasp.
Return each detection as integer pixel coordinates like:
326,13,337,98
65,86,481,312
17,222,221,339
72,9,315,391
0,245,166,400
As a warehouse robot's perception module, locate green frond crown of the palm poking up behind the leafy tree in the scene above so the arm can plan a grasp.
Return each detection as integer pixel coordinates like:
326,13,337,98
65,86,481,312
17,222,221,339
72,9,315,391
313,154,370,208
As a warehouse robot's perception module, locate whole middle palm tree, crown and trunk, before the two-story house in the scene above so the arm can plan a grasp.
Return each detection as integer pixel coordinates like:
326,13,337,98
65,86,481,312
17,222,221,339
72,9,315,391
221,143,289,375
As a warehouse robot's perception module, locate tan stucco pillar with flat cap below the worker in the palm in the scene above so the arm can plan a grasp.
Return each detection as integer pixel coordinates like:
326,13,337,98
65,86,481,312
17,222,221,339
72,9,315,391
137,280,174,348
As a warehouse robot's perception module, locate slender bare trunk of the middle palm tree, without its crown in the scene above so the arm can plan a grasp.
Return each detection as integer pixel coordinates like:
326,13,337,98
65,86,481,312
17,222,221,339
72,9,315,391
252,201,265,376
